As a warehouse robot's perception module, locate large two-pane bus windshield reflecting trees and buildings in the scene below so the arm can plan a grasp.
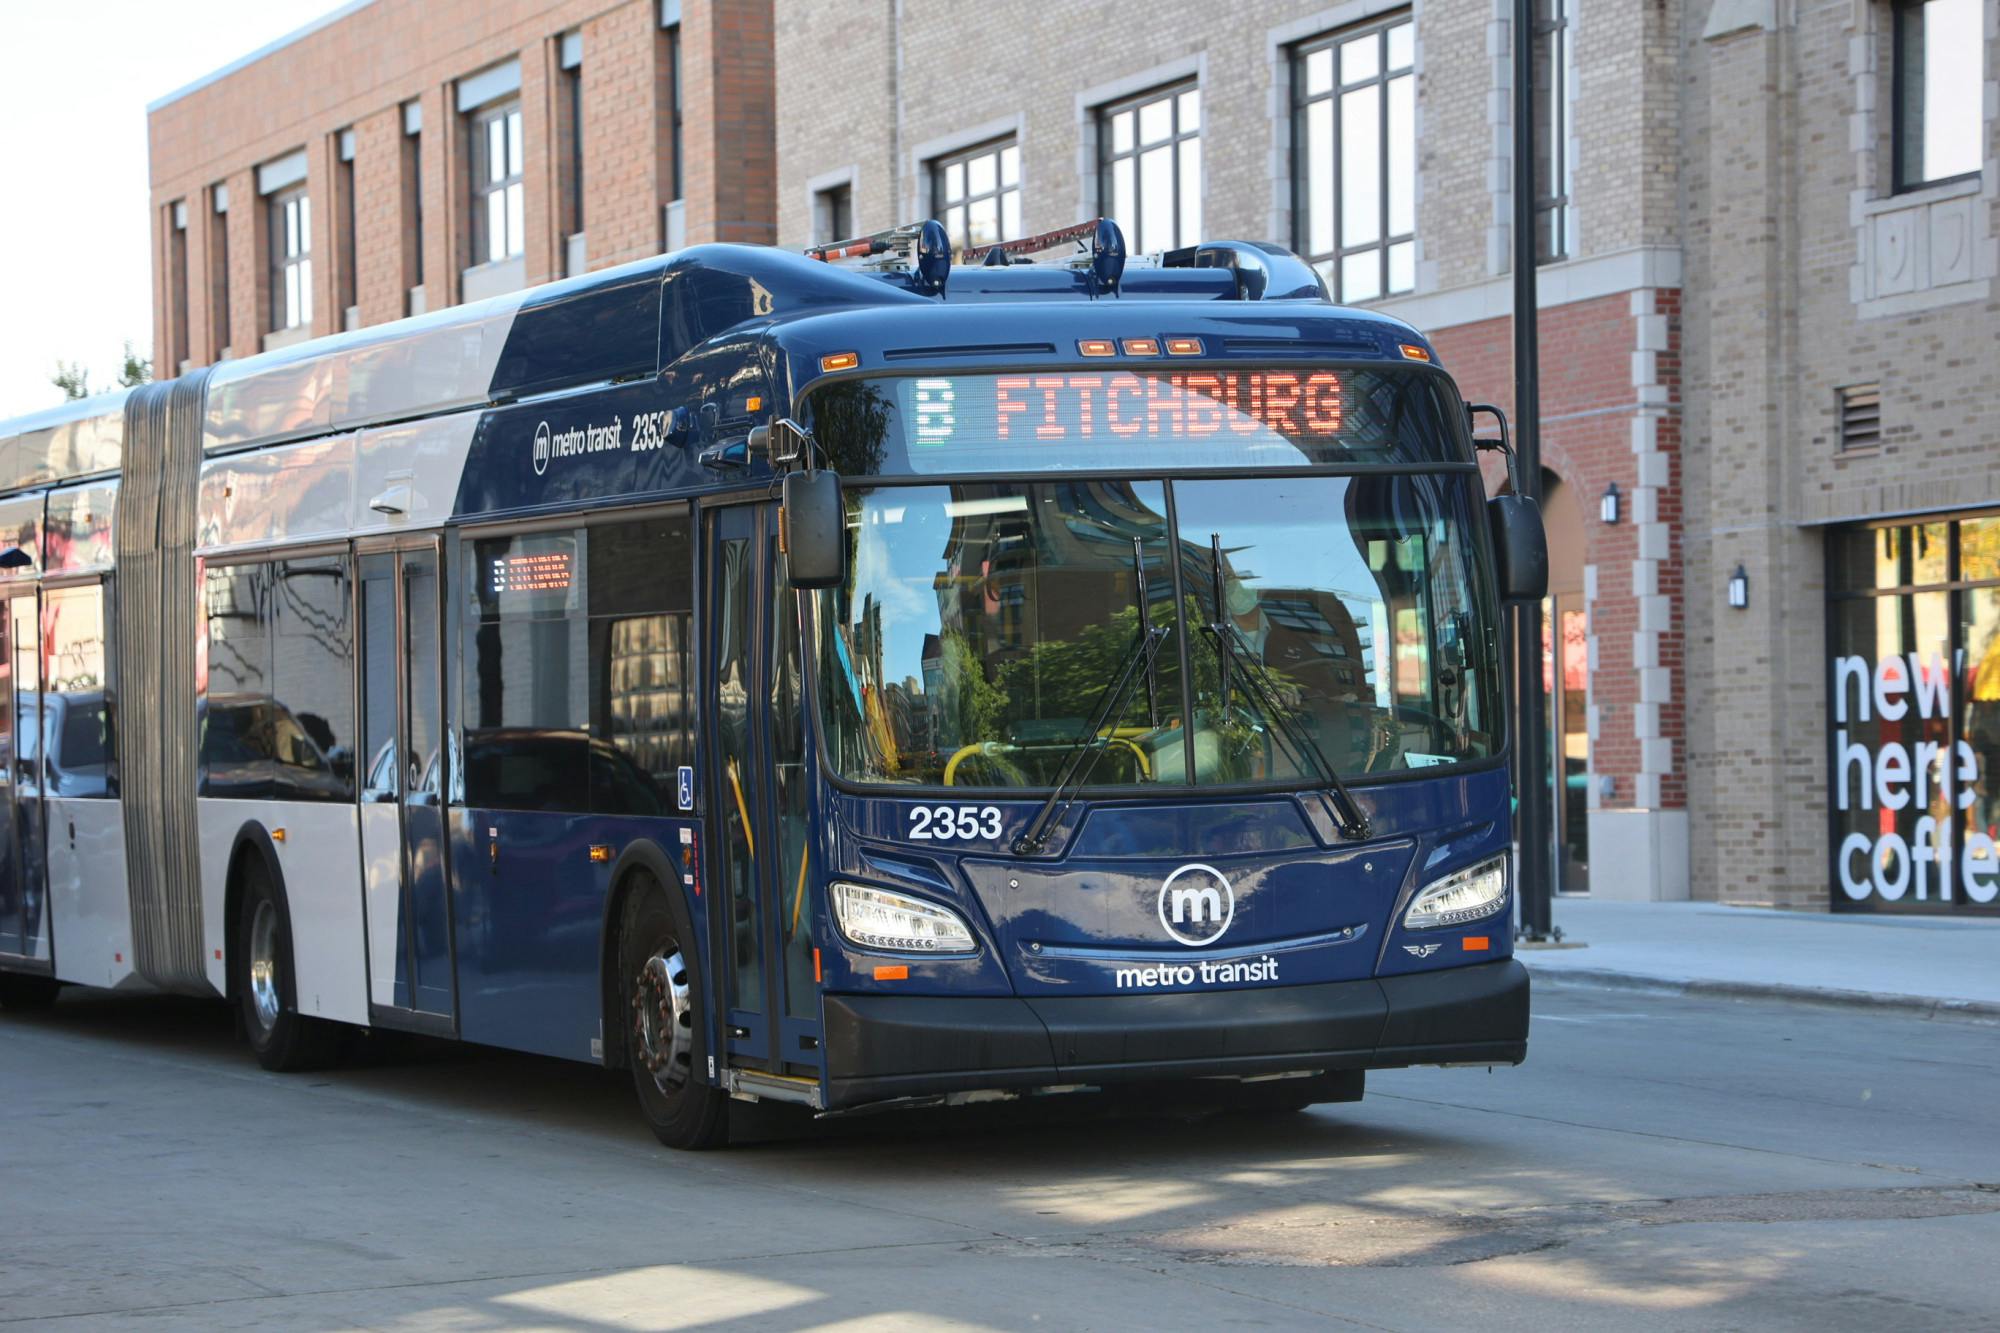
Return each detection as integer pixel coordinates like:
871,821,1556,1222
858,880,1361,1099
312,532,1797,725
818,474,1500,789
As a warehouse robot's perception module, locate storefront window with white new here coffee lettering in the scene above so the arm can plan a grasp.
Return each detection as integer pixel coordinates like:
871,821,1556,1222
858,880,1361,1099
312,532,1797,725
1828,518,2000,915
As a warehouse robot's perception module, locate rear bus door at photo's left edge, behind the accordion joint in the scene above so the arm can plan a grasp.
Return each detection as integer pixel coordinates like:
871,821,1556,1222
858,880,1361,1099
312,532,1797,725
0,588,54,971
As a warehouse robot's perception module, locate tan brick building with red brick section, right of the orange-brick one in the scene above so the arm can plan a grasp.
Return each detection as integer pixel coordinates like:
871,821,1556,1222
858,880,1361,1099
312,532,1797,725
776,0,2000,911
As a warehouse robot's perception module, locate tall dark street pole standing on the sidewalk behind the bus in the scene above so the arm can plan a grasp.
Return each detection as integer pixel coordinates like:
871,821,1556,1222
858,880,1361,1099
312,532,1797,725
1512,0,1556,941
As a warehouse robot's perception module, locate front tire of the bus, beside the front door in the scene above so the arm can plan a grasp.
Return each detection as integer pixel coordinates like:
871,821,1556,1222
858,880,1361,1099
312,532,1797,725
618,873,730,1151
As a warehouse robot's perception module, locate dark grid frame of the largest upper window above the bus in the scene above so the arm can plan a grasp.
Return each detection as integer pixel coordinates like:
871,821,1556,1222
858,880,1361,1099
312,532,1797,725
1292,10,1418,300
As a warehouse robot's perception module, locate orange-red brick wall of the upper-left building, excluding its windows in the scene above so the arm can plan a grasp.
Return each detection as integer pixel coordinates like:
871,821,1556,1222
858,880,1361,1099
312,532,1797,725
148,0,776,362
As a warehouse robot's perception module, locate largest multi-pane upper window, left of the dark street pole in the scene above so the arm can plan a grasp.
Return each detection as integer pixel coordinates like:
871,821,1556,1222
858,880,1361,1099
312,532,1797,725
1292,14,1416,300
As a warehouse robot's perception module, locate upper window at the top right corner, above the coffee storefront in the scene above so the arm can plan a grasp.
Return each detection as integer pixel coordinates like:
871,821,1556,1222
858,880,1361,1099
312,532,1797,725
1894,0,1986,190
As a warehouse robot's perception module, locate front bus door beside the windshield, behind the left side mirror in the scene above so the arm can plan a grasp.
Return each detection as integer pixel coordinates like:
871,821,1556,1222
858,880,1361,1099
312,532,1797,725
702,504,820,1081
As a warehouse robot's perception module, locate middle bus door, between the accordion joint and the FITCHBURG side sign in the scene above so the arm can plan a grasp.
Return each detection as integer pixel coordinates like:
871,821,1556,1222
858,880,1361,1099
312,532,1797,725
360,544,456,1020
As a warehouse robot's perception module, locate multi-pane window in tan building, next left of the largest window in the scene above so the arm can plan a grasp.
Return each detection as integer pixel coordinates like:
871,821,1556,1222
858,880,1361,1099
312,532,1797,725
1098,84,1202,254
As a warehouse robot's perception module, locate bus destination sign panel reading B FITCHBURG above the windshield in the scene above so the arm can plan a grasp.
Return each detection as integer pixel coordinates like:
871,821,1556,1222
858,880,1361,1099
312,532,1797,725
808,366,1472,476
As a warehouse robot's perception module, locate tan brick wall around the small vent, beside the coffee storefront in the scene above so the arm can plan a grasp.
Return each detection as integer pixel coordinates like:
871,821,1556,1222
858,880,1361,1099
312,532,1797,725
1682,0,2000,911
